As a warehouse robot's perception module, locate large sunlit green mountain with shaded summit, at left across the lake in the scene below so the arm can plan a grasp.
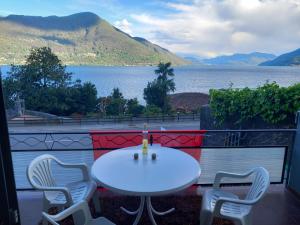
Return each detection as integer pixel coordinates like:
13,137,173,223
0,12,188,65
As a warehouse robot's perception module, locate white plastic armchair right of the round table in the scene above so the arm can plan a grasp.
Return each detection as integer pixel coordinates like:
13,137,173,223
200,167,270,225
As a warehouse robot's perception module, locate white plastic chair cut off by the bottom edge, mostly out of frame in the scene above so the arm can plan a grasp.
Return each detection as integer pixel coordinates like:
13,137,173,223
43,201,115,225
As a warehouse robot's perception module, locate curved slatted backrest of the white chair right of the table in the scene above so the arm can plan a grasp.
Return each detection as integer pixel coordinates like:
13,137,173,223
246,167,270,201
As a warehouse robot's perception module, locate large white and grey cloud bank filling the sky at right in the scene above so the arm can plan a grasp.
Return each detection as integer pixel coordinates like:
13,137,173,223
130,0,300,57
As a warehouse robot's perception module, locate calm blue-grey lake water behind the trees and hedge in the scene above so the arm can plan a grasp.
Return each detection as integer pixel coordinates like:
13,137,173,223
2,66,300,102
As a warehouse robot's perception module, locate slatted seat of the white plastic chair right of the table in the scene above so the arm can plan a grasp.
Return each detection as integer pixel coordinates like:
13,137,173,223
202,189,251,218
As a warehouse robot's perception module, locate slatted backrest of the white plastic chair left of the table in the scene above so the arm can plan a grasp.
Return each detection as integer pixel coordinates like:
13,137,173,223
27,154,58,188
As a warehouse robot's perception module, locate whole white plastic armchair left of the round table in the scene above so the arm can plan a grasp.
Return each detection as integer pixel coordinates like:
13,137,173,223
27,154,100,224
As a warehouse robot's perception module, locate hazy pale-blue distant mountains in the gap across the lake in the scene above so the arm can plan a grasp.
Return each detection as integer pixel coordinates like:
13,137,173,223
202,52,276,66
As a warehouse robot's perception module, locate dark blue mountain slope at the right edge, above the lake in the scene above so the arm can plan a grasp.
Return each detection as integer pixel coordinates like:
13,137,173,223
260,48,300,66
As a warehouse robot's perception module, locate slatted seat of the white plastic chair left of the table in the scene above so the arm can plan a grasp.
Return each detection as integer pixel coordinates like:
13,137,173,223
45,181,97,205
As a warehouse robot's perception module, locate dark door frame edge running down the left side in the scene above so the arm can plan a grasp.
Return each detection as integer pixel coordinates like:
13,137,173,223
0,75,21,225
